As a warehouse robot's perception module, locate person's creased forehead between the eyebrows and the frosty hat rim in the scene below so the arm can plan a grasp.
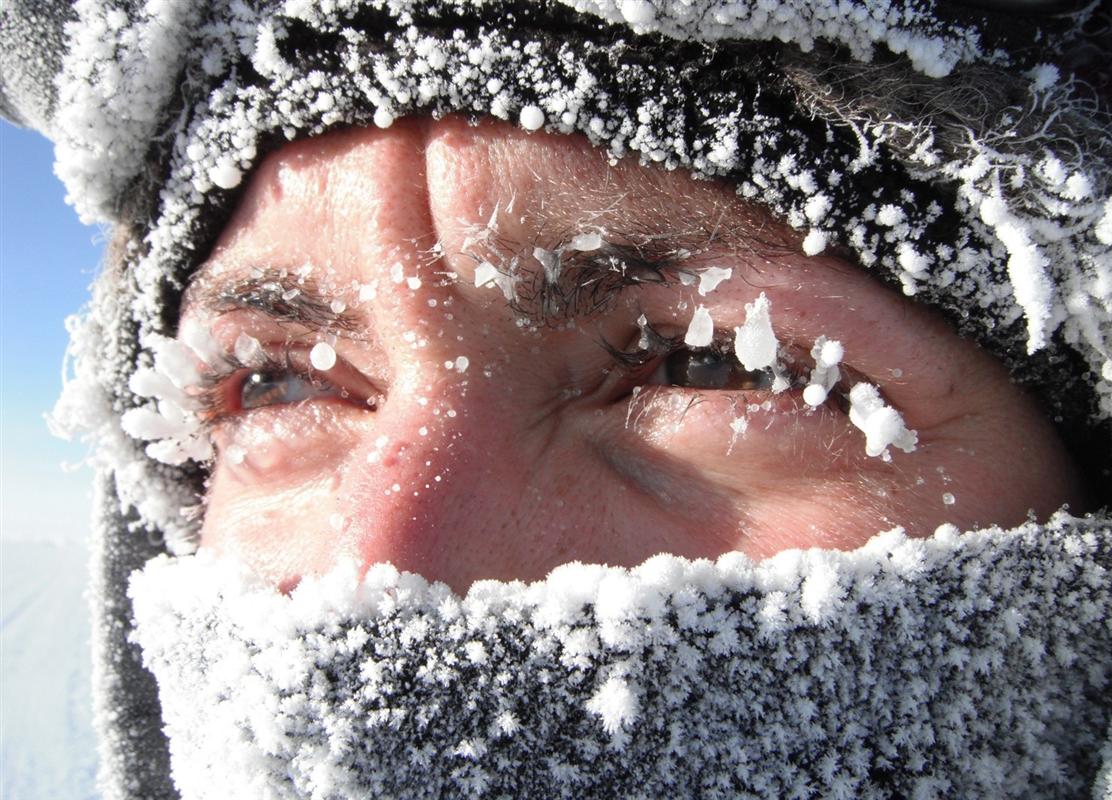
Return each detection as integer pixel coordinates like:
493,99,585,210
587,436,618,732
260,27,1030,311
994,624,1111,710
189,118,794,295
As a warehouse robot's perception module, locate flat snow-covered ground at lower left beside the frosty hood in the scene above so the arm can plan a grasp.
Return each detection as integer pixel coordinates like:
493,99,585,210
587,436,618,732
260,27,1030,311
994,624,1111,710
0,539,97,800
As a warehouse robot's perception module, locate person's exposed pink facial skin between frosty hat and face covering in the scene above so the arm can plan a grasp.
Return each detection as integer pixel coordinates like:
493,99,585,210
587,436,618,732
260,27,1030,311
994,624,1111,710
185,118,1081,591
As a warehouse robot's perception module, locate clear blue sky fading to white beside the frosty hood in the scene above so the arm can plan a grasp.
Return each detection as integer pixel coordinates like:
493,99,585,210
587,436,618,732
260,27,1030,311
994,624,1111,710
0,122,106,541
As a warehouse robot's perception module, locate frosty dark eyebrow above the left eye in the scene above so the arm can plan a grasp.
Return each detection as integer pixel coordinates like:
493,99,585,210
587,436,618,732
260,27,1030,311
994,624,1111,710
182,273,363,333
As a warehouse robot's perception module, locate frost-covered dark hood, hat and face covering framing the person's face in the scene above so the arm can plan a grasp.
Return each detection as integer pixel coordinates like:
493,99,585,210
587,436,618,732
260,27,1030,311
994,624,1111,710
0,0,1112,798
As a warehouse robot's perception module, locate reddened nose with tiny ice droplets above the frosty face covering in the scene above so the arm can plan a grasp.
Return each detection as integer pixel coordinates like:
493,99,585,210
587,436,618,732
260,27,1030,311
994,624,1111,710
344,362,568,589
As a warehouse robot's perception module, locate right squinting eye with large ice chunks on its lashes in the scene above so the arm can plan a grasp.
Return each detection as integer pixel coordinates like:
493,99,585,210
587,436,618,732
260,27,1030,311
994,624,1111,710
587,294,919,480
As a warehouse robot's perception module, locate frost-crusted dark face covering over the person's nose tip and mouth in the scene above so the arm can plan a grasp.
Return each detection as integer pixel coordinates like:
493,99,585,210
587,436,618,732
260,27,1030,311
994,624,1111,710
130,515,1112,798
